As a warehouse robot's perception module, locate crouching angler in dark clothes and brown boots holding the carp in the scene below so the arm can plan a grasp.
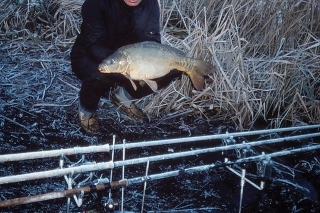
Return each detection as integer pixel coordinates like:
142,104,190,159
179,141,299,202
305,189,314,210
71,0,179,134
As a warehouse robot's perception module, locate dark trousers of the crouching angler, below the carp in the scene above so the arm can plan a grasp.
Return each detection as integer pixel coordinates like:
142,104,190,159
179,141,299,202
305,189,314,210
71,57,181,112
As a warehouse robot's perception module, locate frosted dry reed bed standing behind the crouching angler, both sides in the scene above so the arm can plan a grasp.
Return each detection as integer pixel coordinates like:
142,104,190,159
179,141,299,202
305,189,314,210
0,0,320,130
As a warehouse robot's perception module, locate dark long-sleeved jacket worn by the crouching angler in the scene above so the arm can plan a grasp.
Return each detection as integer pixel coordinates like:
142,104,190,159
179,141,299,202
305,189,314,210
71,0,161,63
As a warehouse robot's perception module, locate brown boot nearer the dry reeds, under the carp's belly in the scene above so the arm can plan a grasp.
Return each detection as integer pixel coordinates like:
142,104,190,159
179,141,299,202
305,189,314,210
111,87,148,122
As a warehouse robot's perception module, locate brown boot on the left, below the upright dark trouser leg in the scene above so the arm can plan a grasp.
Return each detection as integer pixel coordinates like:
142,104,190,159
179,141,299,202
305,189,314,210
79,107,100,135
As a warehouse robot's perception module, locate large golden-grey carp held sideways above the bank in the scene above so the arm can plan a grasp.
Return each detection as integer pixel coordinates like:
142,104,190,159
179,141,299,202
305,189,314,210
99,41,213,91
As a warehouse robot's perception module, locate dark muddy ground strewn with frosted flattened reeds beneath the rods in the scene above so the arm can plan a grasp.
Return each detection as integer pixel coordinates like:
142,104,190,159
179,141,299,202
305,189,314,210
0,47,320,213
